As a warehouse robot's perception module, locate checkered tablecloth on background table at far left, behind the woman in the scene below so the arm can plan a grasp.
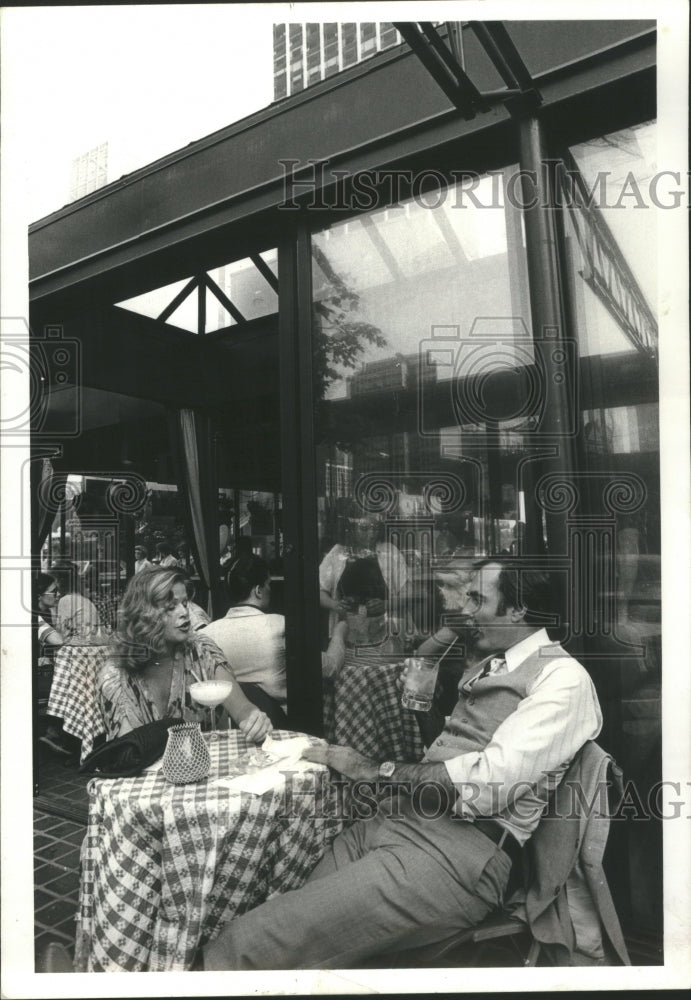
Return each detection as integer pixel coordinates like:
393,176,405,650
48,645,109,760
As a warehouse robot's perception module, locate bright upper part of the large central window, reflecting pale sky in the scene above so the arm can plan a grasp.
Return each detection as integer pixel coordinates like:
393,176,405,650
313,168,532,399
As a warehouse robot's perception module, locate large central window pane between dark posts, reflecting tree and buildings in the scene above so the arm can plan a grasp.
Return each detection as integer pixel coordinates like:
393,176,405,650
312,168,534,652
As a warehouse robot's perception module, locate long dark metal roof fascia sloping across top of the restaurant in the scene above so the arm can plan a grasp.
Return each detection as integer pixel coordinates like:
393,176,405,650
29,21,656,320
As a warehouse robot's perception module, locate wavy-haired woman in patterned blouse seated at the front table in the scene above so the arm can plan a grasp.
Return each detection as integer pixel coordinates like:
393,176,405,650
97,568,272,743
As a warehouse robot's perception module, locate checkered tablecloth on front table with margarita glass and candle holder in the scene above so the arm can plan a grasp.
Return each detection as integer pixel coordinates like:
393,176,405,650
75,731,344,972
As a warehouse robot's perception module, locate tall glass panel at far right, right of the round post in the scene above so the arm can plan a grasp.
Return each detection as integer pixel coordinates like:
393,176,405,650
565,115,662,934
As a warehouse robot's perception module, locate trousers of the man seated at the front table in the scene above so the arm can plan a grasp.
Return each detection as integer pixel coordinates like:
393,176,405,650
204,802,511,970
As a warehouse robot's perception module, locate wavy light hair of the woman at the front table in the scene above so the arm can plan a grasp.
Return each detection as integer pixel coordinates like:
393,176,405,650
111,567,185,670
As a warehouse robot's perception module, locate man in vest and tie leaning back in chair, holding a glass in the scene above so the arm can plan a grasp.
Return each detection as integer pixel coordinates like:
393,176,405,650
200,558,616,970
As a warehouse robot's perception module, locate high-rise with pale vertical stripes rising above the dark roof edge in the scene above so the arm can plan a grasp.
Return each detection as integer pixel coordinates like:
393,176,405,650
274,21,402,101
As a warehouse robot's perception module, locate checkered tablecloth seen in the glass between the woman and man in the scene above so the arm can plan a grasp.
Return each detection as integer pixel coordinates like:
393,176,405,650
323,649,423,762
